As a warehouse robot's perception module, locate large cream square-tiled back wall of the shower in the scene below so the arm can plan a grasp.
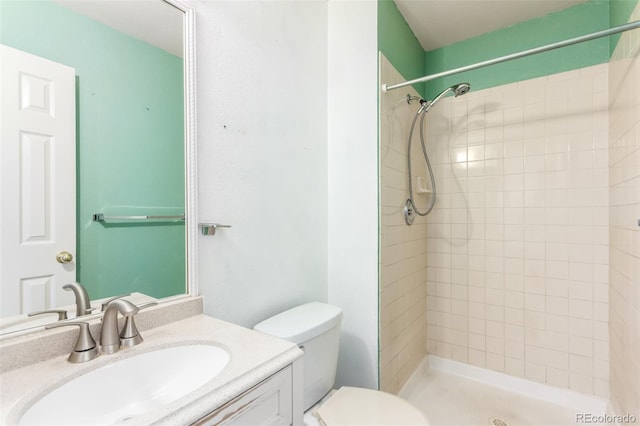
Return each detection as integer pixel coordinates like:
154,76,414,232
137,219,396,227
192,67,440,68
427,64,609,397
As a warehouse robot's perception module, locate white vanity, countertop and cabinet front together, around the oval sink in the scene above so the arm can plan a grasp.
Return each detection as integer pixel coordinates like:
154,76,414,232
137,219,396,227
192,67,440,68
0,310,304,426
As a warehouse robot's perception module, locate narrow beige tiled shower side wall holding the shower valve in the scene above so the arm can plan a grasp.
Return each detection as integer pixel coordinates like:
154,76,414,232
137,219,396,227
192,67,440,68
379,55,428,394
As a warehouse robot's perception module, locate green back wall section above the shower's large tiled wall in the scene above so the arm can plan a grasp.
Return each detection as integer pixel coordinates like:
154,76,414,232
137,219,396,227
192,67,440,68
425,0,609,97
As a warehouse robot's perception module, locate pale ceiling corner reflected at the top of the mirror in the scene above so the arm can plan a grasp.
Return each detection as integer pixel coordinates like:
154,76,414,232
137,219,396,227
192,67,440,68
54,0,184,57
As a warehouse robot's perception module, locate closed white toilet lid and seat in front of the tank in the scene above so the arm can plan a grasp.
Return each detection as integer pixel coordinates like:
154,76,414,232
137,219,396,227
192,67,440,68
317,386,429,426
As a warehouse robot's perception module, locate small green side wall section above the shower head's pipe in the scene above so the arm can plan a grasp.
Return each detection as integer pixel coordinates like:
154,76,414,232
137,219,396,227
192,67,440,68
378,0,425,96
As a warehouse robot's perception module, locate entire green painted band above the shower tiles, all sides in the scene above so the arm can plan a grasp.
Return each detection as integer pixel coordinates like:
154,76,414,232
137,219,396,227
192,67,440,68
378,0,638,98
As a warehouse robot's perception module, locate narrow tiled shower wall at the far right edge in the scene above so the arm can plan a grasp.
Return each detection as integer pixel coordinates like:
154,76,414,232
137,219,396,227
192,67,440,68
609,5,640,418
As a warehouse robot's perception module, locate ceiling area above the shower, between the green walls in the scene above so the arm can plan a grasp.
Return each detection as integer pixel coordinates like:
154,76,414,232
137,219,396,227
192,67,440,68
395,0,587,51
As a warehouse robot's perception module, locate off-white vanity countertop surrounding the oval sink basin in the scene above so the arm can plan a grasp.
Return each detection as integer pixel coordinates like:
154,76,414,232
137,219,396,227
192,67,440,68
0,315,302,425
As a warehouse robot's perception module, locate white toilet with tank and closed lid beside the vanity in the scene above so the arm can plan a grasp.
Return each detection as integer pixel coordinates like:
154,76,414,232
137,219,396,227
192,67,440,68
254,302,429,426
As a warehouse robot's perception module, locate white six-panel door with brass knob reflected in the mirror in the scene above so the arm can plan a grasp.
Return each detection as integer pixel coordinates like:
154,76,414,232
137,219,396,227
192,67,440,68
0,45,76,317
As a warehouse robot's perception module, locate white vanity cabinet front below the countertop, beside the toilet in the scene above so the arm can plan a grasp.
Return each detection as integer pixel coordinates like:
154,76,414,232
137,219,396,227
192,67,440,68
194,366,293,426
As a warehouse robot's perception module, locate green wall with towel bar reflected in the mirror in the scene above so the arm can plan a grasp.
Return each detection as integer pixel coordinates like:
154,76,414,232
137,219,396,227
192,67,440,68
0,0,185,299
